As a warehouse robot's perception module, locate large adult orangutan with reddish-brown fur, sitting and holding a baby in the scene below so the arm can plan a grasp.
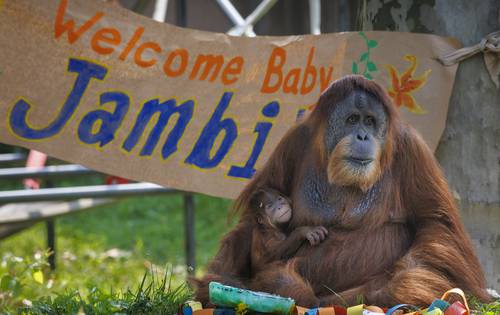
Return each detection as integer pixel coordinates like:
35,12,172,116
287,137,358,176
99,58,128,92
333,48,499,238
193,76,489,306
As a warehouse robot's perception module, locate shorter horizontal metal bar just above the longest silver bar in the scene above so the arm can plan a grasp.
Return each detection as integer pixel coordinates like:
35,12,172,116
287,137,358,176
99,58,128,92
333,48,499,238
0,164,97,179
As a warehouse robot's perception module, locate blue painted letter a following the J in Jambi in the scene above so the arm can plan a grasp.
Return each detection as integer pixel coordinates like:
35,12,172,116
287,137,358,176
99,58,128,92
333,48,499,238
78,92,130,147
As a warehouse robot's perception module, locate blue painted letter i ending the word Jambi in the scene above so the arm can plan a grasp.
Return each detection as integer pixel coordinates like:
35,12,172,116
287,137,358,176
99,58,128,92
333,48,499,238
227,102,280,178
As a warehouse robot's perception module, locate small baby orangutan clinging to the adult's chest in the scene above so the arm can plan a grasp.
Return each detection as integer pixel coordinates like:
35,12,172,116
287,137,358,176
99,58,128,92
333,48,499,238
250,189,328,274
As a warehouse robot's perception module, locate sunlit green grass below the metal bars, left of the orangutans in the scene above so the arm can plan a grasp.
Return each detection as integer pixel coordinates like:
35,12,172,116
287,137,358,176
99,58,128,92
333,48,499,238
0,168,234,314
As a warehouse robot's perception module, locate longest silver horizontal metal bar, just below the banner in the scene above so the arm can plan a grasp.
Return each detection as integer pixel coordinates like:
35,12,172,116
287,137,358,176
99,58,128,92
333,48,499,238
0,183,177,204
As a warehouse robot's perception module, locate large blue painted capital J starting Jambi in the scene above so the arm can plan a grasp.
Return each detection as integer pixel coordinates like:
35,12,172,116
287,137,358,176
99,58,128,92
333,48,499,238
10,58,108,139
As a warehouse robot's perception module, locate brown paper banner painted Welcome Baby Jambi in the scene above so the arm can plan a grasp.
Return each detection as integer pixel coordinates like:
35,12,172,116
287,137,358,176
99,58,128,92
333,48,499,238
0,0,458,198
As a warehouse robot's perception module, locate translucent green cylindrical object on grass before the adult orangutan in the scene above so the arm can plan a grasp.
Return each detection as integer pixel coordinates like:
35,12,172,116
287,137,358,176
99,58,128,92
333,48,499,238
208,282,295,315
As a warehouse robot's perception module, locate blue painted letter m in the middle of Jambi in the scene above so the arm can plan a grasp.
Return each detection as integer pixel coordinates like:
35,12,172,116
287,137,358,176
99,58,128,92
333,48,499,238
122,99,194,159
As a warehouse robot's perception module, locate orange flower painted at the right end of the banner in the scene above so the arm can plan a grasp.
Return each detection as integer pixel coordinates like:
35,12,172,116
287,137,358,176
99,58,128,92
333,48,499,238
386,55,431,114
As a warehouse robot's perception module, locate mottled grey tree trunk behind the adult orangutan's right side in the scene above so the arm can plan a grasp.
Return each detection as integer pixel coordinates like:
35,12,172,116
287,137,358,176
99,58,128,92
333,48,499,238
362,0,500,291
